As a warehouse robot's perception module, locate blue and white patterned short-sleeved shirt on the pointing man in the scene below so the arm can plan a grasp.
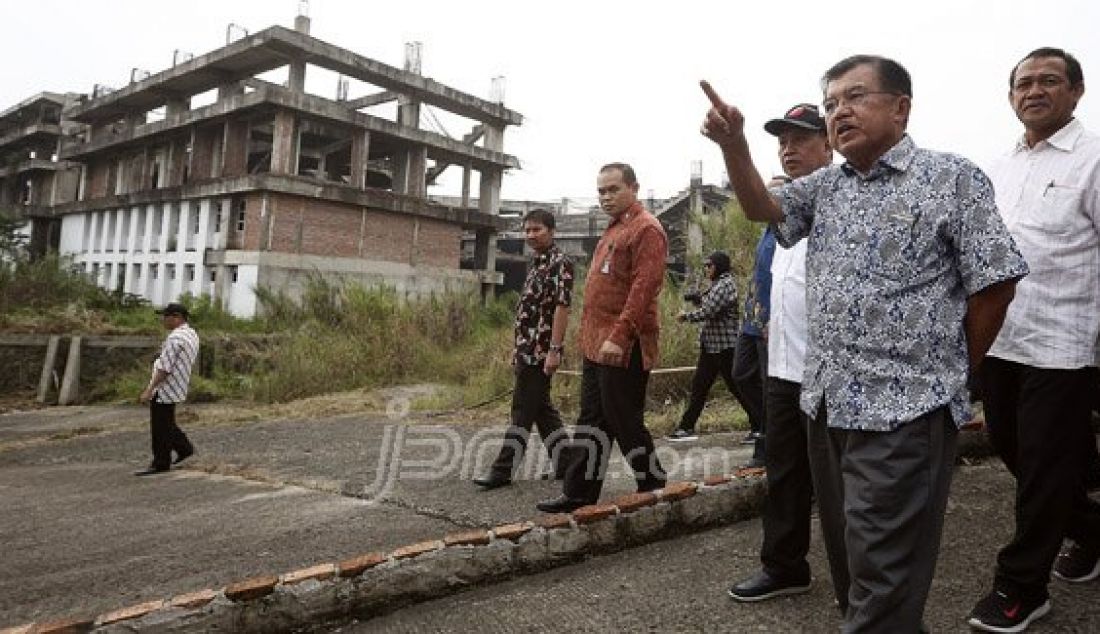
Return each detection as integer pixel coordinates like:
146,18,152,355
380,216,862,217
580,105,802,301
776,135,1027,431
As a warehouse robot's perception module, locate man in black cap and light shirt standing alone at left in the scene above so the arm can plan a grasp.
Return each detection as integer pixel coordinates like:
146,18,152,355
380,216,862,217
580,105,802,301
134,304,199,476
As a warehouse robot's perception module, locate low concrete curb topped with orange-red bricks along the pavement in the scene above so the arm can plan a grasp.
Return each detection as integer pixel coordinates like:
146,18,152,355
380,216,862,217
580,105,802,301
0,427,991,634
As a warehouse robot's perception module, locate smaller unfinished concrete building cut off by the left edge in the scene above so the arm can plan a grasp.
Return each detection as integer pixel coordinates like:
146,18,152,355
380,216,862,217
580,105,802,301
0,92,80,253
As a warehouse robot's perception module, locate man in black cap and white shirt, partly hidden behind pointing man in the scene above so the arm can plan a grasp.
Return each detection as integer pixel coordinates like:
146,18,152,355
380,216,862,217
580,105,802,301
729,103,848,606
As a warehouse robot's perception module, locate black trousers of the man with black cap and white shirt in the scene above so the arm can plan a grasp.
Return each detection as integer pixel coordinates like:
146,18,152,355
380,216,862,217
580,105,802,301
760,376,813,582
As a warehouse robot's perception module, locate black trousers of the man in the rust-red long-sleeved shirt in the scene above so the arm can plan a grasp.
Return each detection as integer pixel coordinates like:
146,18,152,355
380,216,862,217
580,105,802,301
562,343,667,502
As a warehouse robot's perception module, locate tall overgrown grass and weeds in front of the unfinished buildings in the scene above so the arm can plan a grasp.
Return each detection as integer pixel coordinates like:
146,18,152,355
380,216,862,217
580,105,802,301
0,198,761,428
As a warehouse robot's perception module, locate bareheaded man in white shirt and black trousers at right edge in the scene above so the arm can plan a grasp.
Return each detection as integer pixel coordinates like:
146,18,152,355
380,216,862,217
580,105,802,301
969,48,1100,632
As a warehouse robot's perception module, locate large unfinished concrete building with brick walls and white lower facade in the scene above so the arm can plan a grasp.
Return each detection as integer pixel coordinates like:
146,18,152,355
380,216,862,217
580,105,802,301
51,15,521,316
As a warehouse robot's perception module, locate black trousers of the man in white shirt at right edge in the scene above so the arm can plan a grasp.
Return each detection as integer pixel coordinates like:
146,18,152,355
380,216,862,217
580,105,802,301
980,357,1100,592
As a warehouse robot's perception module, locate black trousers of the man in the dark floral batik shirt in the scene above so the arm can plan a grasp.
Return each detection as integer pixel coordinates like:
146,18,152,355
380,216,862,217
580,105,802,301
491,363,567,478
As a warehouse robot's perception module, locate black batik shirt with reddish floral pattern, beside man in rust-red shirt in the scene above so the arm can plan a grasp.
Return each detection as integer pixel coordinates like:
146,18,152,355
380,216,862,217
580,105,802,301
515,244,573,365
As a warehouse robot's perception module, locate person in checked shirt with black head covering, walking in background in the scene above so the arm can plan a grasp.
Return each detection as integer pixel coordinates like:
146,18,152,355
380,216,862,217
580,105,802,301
669,251,737,441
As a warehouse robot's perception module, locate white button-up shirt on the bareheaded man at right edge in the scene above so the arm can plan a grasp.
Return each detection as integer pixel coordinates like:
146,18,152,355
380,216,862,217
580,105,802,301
989,119,1100,370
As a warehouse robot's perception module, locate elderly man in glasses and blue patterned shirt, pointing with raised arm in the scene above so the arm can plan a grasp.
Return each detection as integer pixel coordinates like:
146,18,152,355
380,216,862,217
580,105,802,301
703,55,1027,634
